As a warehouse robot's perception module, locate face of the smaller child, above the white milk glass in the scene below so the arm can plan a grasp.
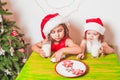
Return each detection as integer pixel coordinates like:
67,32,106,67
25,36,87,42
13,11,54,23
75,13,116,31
86,30,100,40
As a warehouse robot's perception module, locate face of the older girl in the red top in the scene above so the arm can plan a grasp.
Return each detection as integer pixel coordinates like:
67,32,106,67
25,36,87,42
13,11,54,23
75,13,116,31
50,25,65,41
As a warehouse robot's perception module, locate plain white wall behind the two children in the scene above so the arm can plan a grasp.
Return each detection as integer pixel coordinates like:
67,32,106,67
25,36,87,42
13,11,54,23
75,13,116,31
2,0,120,58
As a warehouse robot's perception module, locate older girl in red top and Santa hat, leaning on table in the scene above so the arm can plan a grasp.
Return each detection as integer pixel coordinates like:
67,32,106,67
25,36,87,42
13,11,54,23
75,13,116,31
32,13,81,62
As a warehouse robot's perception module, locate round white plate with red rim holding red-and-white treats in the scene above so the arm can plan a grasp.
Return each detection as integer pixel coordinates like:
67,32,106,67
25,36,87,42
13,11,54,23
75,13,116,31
55,60,87,77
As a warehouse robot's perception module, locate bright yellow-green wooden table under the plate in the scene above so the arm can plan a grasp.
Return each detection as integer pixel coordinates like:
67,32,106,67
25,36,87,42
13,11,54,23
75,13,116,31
16,52,120,80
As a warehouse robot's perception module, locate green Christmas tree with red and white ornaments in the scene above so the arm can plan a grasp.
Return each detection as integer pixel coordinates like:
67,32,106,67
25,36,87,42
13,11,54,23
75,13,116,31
0,1,28,80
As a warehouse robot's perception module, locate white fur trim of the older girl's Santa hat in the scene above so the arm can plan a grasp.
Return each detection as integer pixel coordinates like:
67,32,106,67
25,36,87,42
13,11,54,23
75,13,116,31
43,15,63,36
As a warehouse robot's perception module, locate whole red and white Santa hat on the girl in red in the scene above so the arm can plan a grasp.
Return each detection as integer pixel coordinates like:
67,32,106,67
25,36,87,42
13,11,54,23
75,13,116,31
41,13,63,39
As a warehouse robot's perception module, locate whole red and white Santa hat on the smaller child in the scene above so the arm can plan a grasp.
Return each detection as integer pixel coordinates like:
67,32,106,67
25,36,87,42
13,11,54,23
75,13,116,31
84,18,105,35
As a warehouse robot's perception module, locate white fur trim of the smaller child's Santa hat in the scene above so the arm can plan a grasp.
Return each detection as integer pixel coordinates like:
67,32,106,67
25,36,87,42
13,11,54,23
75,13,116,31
84,22,105,35
